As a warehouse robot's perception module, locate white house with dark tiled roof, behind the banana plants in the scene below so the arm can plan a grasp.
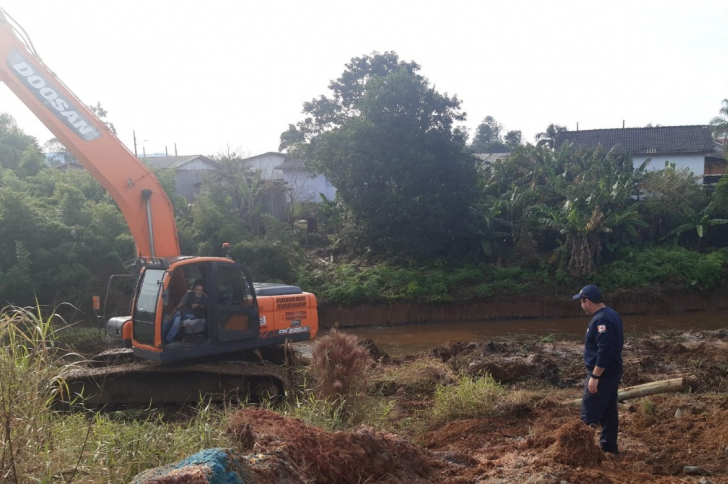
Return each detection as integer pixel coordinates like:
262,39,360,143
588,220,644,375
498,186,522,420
555,126,725,183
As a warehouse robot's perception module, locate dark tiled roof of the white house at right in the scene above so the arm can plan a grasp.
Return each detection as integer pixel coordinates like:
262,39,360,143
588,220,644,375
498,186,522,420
555,126,715,155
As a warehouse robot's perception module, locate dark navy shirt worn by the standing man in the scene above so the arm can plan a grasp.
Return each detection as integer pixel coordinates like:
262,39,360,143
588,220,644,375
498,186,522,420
584,306,624,378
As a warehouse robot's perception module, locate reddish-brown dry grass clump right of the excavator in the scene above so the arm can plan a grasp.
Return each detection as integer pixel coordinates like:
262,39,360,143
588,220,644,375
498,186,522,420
311,329,371,402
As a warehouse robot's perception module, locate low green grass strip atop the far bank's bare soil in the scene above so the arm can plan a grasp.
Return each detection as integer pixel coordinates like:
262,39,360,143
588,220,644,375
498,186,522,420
296,246,728,305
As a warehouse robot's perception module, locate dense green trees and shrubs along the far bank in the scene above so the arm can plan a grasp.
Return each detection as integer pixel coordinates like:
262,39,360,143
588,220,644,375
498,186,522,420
0,52,728,319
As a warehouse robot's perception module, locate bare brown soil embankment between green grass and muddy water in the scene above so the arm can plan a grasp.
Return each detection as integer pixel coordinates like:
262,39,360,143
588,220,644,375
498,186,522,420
319,291,728,329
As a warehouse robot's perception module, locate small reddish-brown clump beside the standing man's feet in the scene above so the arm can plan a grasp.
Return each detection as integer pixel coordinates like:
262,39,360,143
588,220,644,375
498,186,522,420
548,420,603,467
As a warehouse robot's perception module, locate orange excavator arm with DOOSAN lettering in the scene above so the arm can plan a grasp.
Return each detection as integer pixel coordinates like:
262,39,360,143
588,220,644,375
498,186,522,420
0,8,180,258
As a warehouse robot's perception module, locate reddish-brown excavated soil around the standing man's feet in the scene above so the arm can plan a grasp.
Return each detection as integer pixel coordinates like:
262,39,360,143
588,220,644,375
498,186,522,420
155,330,728,484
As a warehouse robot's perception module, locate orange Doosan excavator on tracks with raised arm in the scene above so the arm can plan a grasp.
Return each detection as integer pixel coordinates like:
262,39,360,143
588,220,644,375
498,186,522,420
0,8,318,403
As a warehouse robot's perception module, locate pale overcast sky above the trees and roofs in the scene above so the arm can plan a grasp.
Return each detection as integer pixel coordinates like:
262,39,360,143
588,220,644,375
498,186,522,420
0,0,728,155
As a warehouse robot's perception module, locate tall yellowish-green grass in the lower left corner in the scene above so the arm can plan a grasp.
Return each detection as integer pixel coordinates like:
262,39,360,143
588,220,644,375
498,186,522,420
0,307,232,483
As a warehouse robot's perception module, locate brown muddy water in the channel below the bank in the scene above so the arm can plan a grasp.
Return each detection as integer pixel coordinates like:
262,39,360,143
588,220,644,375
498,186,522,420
342,311,728,356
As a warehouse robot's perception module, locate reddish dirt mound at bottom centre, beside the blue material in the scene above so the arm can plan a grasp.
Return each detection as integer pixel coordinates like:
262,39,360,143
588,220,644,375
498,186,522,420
228,409,468,484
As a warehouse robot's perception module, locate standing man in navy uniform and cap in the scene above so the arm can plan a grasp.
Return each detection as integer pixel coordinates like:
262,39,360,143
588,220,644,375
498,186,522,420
573,285,624,454
